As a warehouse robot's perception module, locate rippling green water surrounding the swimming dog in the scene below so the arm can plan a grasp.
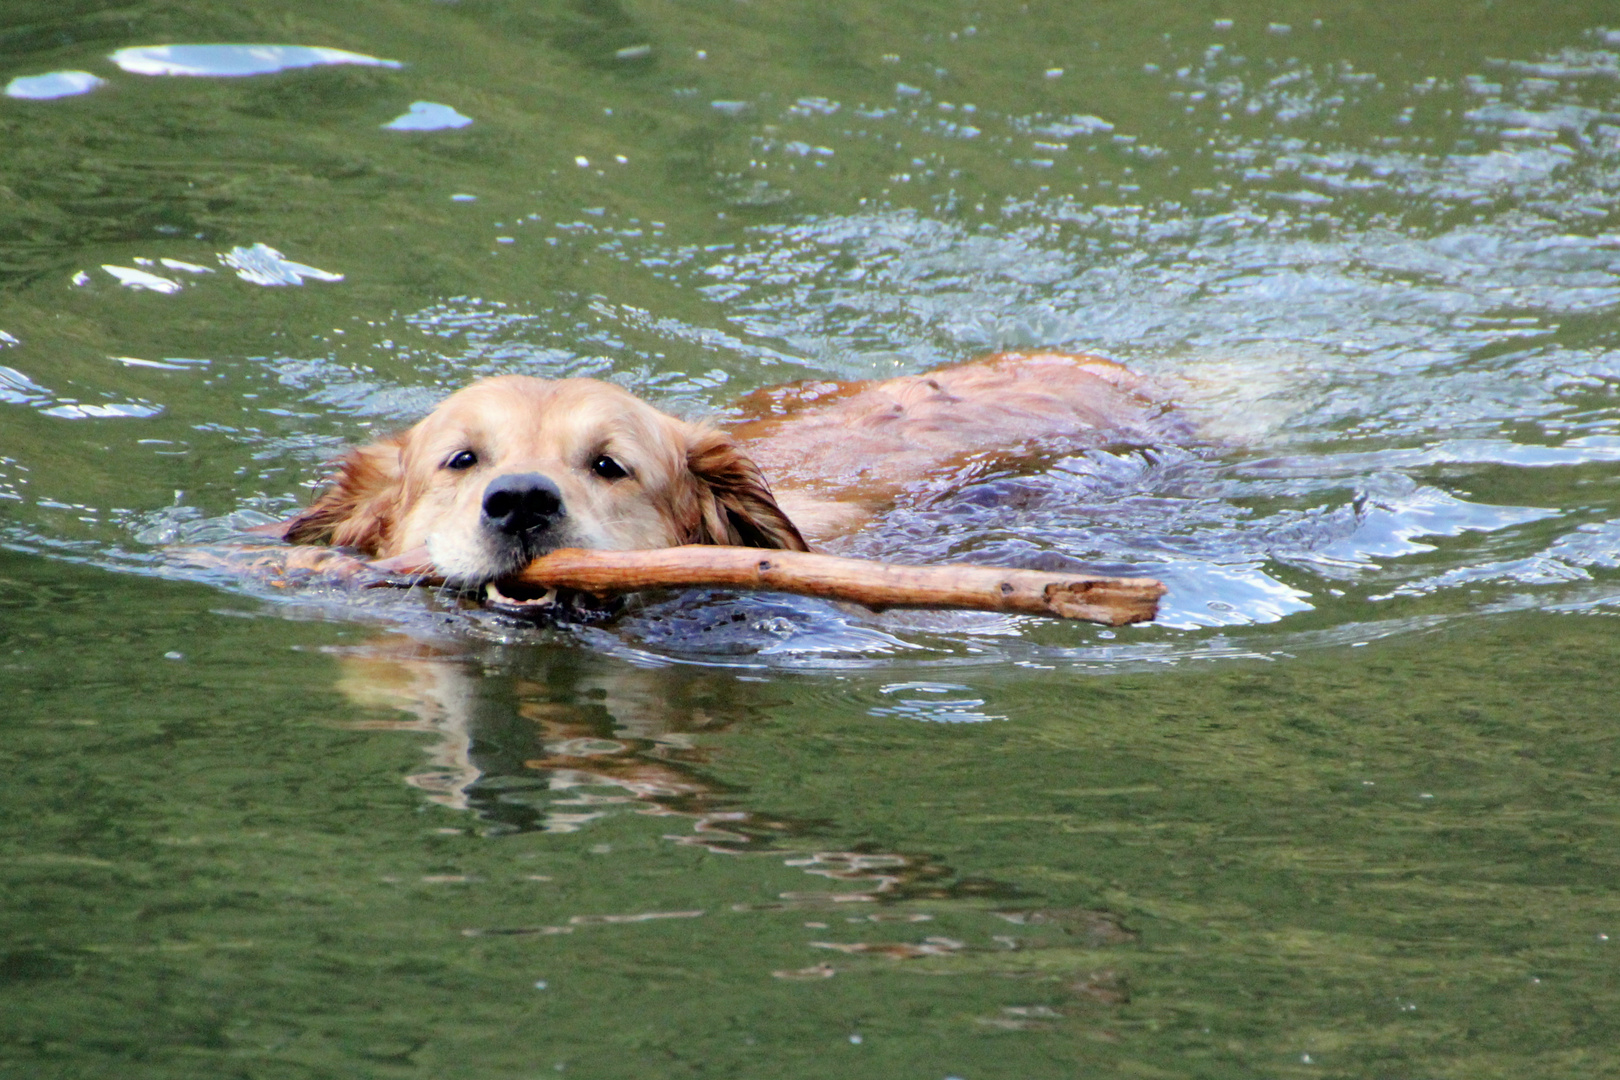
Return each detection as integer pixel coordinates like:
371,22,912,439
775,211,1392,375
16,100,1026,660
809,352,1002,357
0,0,1620,1080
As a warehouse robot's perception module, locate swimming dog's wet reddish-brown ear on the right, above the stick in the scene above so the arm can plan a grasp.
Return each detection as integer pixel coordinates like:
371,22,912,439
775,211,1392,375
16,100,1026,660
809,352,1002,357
684,429,810,551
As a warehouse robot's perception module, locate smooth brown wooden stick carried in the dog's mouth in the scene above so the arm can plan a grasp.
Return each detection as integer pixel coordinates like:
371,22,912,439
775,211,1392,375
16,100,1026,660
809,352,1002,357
387,544,1165,627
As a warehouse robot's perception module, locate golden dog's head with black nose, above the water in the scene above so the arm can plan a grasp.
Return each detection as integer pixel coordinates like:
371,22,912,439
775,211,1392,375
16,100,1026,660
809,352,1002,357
285,376,805,585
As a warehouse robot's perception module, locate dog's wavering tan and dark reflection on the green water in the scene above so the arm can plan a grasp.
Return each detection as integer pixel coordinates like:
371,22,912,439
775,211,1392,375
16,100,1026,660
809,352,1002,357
340,636,1000,904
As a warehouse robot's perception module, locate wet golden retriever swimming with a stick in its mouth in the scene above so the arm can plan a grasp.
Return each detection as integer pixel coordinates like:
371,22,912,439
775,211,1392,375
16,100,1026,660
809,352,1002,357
284,353,1165,588
